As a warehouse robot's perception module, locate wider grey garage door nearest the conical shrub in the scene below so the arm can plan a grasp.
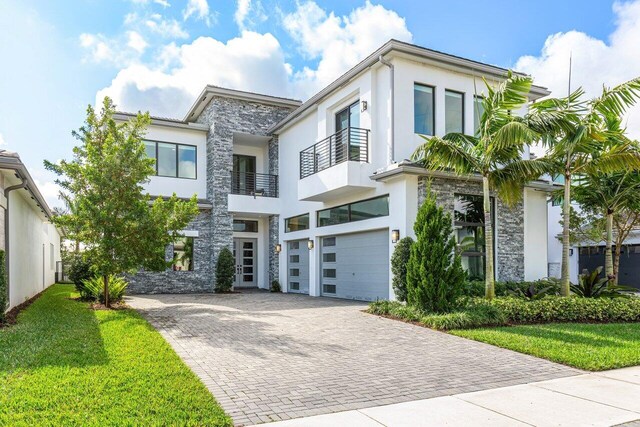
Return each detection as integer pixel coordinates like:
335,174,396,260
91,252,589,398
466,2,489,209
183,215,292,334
320,229,389,301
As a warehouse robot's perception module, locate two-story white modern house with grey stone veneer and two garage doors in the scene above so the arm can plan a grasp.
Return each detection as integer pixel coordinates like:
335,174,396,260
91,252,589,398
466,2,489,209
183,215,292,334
117,40,551,300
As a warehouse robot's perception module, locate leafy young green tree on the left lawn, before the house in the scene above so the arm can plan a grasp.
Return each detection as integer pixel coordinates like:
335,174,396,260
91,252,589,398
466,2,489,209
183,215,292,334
45,98,198,307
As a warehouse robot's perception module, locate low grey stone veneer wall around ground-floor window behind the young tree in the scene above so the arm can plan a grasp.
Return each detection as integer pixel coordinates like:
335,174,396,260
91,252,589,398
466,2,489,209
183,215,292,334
127,209,214,294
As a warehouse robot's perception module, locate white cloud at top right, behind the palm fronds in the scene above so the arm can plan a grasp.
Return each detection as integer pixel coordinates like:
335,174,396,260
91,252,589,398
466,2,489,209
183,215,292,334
515,0,640,138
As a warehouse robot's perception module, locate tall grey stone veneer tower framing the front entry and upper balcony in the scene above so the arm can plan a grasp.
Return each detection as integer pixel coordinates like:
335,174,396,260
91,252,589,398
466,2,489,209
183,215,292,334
196,96,291,285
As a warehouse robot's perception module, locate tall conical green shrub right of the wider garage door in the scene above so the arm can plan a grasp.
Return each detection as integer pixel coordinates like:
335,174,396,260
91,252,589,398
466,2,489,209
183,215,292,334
407,193,466,313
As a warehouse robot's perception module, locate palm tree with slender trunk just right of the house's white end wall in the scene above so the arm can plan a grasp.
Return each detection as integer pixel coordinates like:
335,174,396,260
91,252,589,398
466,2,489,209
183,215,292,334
526,78,640,296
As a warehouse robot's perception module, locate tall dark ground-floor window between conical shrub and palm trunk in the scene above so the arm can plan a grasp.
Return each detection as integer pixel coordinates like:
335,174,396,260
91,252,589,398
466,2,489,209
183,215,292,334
454,194,495,280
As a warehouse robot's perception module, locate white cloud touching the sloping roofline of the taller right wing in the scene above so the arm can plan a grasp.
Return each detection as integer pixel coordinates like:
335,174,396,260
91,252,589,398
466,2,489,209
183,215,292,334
284,1,412,95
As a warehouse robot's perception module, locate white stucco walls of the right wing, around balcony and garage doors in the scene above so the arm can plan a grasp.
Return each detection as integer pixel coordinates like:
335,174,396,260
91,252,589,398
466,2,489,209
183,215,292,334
277,54,547,297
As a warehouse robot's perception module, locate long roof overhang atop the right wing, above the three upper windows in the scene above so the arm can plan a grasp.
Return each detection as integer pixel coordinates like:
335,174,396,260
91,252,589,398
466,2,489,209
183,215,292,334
268,39,551,133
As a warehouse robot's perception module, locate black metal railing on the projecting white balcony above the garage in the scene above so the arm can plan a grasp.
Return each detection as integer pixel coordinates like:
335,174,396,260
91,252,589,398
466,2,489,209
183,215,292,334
300,127,369,179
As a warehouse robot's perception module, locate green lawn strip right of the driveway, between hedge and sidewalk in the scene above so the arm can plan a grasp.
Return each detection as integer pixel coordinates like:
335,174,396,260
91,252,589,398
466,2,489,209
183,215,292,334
450,323,640,371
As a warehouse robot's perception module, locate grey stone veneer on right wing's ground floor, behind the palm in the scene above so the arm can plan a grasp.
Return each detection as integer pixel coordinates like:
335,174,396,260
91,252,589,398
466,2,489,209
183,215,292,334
418,177,524,281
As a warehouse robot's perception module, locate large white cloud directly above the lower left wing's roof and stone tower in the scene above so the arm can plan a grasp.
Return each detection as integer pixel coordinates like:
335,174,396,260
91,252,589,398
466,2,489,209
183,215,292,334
96,31,289,117
